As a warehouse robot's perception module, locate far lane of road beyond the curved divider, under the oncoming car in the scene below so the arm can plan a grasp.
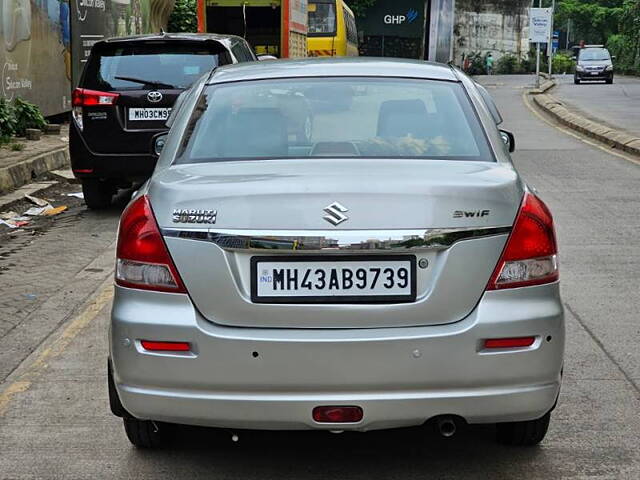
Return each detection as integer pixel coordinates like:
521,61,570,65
551,75,640,137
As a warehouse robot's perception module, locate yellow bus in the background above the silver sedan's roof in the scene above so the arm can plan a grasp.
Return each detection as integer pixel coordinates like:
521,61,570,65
307,0,358,57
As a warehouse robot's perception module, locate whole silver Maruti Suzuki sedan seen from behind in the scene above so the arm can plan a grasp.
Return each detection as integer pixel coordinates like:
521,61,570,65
109,59,564,447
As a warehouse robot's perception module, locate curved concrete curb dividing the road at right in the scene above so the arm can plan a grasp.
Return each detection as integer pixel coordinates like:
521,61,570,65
531,86,640,156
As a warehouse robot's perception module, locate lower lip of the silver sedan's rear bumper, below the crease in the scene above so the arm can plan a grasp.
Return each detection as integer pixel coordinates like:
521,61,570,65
118,381,560,431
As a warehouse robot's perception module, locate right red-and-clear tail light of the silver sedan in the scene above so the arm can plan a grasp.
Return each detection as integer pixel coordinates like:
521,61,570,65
487,192,558,290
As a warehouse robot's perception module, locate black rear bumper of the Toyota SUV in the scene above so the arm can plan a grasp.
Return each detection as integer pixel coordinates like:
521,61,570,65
69,119,157,181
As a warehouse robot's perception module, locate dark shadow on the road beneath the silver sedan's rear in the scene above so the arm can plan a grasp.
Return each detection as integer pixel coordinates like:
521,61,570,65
121,426,550,479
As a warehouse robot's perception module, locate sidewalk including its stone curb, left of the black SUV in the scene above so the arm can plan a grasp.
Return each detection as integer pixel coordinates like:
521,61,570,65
0,126,69,194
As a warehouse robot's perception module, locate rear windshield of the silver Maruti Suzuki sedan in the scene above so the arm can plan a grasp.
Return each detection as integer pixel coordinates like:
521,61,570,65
176,77,494,163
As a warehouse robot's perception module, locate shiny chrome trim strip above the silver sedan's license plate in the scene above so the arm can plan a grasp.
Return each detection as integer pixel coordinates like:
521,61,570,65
162,226,511,253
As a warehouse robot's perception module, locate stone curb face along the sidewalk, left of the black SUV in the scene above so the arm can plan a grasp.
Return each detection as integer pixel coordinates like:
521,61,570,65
0,146,70,192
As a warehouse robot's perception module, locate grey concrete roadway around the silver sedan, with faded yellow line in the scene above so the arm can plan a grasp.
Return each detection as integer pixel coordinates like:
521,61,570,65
0,76,640,480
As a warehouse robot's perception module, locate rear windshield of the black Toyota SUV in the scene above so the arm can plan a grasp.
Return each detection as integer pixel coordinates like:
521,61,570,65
82,42,226,91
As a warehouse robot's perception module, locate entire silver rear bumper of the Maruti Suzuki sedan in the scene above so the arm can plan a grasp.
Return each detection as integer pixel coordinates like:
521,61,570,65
110,284,564,430
